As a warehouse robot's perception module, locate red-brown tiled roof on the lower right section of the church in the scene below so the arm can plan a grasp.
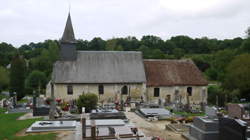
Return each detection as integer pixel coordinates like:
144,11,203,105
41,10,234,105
144,59,208,86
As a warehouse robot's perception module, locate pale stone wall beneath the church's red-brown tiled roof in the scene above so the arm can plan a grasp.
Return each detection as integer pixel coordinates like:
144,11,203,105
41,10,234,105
146,86,207,104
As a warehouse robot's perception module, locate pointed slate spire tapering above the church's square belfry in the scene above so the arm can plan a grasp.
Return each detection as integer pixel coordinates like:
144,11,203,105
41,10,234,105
61,13,76,43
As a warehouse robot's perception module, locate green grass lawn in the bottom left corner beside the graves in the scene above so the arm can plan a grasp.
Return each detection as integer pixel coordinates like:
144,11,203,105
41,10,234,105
0,113,56,140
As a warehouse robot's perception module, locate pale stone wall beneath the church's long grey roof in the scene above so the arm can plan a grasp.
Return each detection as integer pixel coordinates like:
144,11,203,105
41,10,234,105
46,84,146,102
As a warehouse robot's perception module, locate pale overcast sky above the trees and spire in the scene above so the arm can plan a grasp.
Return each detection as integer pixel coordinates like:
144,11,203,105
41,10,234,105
0,0,250,47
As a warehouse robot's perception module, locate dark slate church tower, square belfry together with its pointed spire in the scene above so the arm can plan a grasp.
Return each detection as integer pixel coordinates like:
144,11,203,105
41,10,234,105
59,13,77,61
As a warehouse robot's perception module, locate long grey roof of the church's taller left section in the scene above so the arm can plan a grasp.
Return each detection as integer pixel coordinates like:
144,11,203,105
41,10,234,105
53,51,146,83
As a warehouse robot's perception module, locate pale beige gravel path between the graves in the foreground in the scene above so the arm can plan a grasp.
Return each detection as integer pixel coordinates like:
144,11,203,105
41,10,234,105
125,112,185,140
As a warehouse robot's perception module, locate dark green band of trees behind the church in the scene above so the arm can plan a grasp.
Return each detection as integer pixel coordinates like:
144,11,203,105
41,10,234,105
0,32,250,101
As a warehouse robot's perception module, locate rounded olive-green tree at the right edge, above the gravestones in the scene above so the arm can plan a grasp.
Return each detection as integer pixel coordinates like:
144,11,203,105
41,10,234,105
223,54,250,99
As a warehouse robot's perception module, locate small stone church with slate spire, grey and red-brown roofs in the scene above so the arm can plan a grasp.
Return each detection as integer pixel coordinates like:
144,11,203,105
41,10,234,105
46,14,208,104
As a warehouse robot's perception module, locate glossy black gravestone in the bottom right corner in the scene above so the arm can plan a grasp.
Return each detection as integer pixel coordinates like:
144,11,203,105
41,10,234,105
219,118,247,140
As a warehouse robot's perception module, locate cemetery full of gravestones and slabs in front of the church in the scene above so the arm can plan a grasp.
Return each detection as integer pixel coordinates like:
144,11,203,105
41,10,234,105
1,89,250,140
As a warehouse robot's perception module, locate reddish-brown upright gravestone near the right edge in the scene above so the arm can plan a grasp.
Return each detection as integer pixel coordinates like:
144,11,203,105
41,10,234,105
227,104,245,119
